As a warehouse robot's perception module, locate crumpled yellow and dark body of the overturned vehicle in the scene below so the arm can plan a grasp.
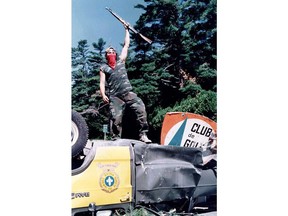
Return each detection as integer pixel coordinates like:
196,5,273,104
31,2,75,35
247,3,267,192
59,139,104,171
71,110,217,216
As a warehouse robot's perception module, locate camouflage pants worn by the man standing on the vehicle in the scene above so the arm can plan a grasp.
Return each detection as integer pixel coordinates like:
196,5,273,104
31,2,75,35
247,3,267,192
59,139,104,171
109,92,148,137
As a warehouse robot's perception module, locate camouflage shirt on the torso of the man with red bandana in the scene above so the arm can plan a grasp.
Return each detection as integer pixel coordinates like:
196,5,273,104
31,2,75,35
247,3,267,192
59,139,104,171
101,60,132,96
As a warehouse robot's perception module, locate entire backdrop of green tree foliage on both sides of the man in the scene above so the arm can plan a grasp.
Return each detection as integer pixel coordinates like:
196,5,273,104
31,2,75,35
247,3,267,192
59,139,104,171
72,0,217,142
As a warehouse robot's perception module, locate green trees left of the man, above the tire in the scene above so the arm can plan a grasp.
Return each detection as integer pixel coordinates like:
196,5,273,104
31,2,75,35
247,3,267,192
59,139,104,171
72,38,109,138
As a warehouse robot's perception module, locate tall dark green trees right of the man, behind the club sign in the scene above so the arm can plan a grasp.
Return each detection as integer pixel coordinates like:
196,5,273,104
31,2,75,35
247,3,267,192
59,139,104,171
132,0,217,140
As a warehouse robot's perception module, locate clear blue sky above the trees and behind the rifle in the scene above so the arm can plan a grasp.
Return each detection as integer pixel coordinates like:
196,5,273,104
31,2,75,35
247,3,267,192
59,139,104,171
72,0,145,49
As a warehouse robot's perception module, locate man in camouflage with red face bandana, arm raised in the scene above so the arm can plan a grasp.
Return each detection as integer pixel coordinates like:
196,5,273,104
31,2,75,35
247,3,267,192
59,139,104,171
100,25,151,143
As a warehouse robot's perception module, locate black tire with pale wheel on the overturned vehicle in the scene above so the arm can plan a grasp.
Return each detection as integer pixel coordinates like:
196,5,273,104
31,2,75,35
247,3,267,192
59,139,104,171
71,110,88,158
